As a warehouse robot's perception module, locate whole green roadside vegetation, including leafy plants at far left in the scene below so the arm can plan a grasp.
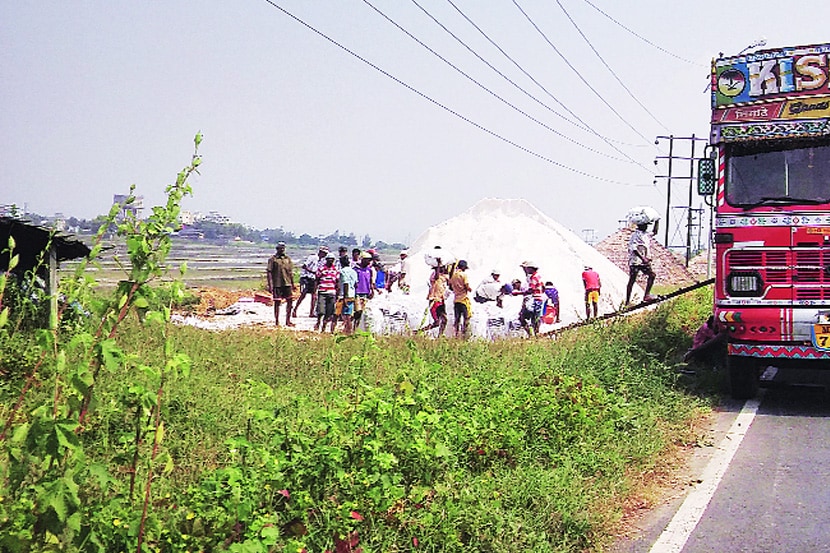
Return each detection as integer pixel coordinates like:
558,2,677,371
0,175,711,553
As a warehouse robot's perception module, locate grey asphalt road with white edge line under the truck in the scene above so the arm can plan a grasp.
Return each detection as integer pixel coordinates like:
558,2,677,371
612,373,830,553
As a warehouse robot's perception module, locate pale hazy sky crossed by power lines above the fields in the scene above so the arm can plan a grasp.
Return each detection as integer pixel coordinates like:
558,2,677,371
0,0,830,242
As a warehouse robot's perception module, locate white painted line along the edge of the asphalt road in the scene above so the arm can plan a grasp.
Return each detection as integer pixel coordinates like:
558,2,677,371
650,396,762,553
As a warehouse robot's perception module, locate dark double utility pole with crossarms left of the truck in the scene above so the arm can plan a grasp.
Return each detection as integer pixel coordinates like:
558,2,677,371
654,134,708,266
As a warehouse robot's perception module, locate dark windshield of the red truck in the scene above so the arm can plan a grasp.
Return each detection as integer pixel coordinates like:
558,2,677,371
726,139,830,208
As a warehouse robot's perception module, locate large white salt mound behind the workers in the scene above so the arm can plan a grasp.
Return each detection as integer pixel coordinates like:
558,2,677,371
367,198,642,337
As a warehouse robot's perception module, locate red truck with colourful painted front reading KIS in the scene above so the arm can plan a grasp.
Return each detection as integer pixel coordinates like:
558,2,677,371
698,44,830,398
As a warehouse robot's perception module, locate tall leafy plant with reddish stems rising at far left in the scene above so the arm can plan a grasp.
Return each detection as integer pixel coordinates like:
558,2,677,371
0,135,201,552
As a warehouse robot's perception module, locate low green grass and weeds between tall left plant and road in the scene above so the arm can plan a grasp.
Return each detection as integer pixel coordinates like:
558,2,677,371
0,291,711,552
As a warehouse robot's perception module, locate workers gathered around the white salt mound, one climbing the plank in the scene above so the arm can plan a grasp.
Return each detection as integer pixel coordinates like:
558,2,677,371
267,216,655,337
